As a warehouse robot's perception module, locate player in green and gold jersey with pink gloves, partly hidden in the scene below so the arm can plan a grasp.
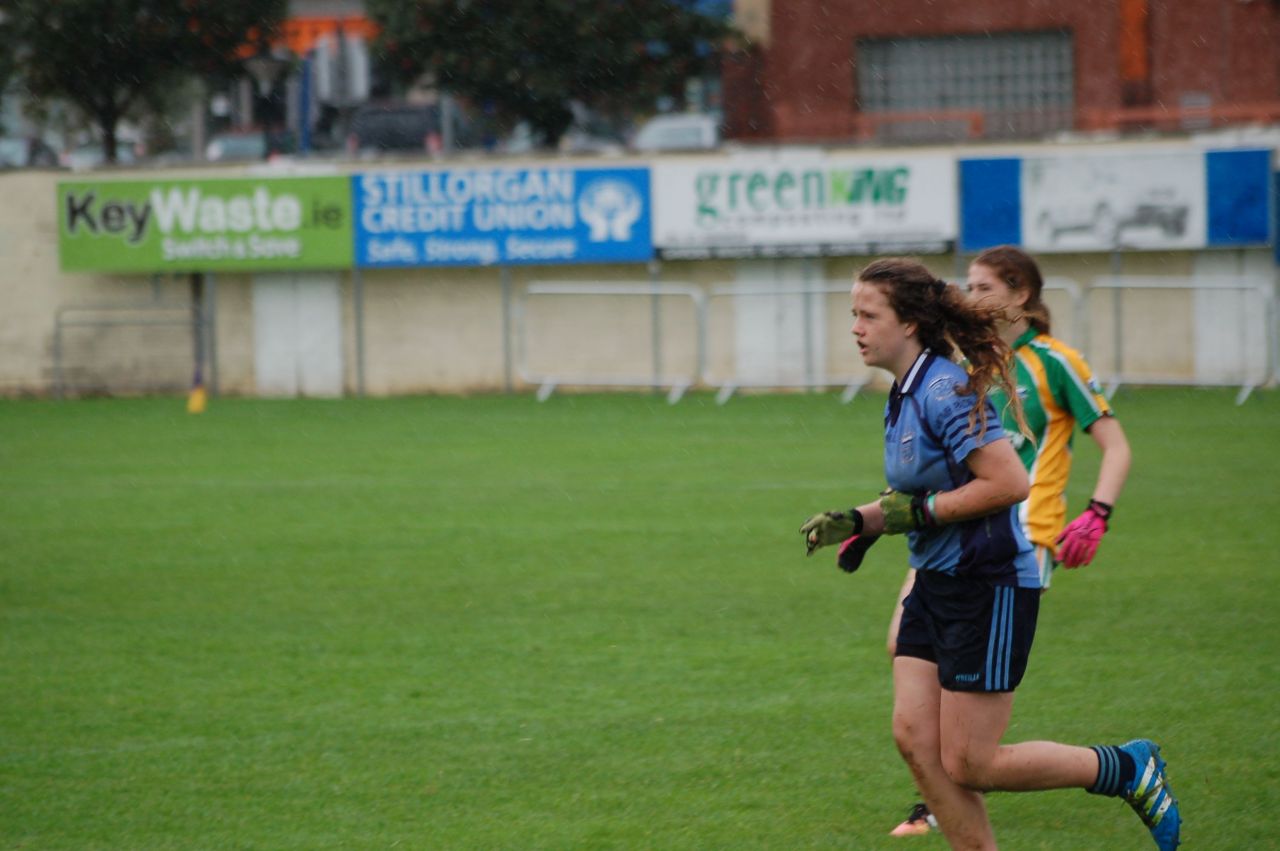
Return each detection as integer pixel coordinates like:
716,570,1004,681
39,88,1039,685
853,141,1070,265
888,246,1130,836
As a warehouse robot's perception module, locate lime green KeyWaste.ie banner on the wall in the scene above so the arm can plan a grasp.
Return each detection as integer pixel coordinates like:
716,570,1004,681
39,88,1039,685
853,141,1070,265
58,175,353,273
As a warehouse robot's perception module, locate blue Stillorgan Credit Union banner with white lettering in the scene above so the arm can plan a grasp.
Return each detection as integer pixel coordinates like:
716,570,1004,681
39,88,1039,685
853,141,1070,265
351,166,653,269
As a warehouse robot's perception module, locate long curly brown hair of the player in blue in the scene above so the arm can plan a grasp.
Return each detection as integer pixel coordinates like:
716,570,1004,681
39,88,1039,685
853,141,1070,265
856,257,1030,438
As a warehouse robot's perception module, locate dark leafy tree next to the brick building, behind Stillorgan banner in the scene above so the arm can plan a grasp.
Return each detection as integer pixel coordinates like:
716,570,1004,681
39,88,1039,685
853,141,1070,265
365,0,732,145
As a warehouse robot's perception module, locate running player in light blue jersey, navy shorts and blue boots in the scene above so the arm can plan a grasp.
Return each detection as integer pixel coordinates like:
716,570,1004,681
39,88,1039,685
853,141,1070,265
800,258,1180,851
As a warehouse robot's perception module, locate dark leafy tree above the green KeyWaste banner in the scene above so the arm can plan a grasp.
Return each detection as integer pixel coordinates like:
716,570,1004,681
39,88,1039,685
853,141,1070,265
0,0,287,163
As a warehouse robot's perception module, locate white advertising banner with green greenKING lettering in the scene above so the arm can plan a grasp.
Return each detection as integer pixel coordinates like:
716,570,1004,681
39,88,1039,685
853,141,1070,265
654,150,959,257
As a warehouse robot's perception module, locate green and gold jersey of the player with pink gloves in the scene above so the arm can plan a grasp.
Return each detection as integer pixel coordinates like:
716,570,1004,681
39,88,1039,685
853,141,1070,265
991,329,1111,549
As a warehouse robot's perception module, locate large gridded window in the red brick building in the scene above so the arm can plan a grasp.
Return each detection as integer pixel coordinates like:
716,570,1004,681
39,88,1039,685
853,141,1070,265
855,32,1075,141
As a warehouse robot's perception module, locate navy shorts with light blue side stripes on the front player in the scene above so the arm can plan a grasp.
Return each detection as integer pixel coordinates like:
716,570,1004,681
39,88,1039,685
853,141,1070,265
896,571,1041,691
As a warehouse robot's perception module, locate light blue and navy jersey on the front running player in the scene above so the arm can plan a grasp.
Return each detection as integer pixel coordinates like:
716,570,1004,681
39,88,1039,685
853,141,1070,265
884,349,1041,587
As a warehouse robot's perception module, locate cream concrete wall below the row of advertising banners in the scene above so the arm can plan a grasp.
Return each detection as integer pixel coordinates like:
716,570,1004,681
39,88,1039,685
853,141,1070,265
0,161,1275,395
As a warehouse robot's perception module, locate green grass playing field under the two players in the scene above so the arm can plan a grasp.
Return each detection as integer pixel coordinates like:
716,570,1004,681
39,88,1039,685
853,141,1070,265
0,390,1280,851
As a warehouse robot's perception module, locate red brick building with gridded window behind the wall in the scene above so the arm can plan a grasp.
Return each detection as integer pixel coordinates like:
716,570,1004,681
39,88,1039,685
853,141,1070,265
724,0,1280,142
